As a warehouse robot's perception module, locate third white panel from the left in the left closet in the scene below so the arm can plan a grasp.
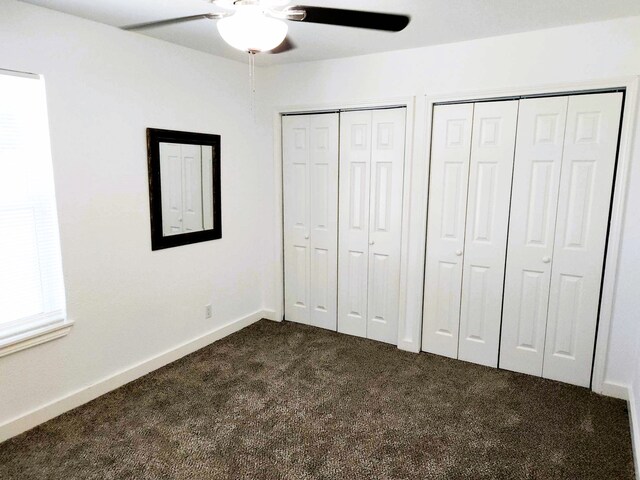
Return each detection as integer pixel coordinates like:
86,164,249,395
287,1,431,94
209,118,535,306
338,111,373,337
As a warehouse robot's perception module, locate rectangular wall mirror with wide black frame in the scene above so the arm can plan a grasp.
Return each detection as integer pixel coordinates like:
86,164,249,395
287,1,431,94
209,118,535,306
147,128,222,250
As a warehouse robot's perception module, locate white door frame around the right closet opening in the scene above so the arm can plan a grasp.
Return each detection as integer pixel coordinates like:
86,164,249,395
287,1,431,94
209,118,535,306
422,77,640,400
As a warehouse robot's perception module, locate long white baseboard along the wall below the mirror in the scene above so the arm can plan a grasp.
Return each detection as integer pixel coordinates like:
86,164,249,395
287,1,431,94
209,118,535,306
0,310,270,442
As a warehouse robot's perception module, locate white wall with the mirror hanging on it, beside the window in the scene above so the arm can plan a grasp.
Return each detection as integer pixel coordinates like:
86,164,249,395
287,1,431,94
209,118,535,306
0,0,264,426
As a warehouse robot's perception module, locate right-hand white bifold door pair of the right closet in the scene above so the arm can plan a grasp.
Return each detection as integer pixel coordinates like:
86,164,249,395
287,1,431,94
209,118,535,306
500,93,622,387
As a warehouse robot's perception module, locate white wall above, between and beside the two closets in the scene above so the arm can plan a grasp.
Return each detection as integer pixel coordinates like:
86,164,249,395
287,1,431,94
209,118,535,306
260,17,640,394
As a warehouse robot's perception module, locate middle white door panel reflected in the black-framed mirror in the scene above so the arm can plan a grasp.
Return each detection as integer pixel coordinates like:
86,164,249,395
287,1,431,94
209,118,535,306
181,145,203,232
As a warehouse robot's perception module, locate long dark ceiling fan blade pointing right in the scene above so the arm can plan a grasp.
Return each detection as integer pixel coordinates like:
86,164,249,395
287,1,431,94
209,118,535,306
284,5,410,32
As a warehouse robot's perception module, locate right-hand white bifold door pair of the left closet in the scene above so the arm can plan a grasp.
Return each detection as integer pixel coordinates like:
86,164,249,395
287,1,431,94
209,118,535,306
338,108,406,344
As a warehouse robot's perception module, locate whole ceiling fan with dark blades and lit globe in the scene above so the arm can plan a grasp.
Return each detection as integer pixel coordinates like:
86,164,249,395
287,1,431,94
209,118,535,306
122,0,409,54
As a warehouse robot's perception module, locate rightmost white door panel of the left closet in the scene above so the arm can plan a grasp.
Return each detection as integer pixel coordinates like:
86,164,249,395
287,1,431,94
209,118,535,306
367,108,406,345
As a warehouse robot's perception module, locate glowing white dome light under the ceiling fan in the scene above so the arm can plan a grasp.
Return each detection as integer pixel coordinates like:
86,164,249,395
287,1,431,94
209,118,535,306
218,5,288,52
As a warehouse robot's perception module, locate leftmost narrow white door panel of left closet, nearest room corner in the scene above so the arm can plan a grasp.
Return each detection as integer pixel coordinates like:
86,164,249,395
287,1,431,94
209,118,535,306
282,115,311,324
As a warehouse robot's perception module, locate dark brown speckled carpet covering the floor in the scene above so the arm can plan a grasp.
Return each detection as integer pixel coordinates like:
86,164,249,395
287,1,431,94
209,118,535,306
0,320,633,480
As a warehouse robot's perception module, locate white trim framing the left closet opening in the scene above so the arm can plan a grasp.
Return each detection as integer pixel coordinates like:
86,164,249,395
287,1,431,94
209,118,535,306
273,96,421,352
